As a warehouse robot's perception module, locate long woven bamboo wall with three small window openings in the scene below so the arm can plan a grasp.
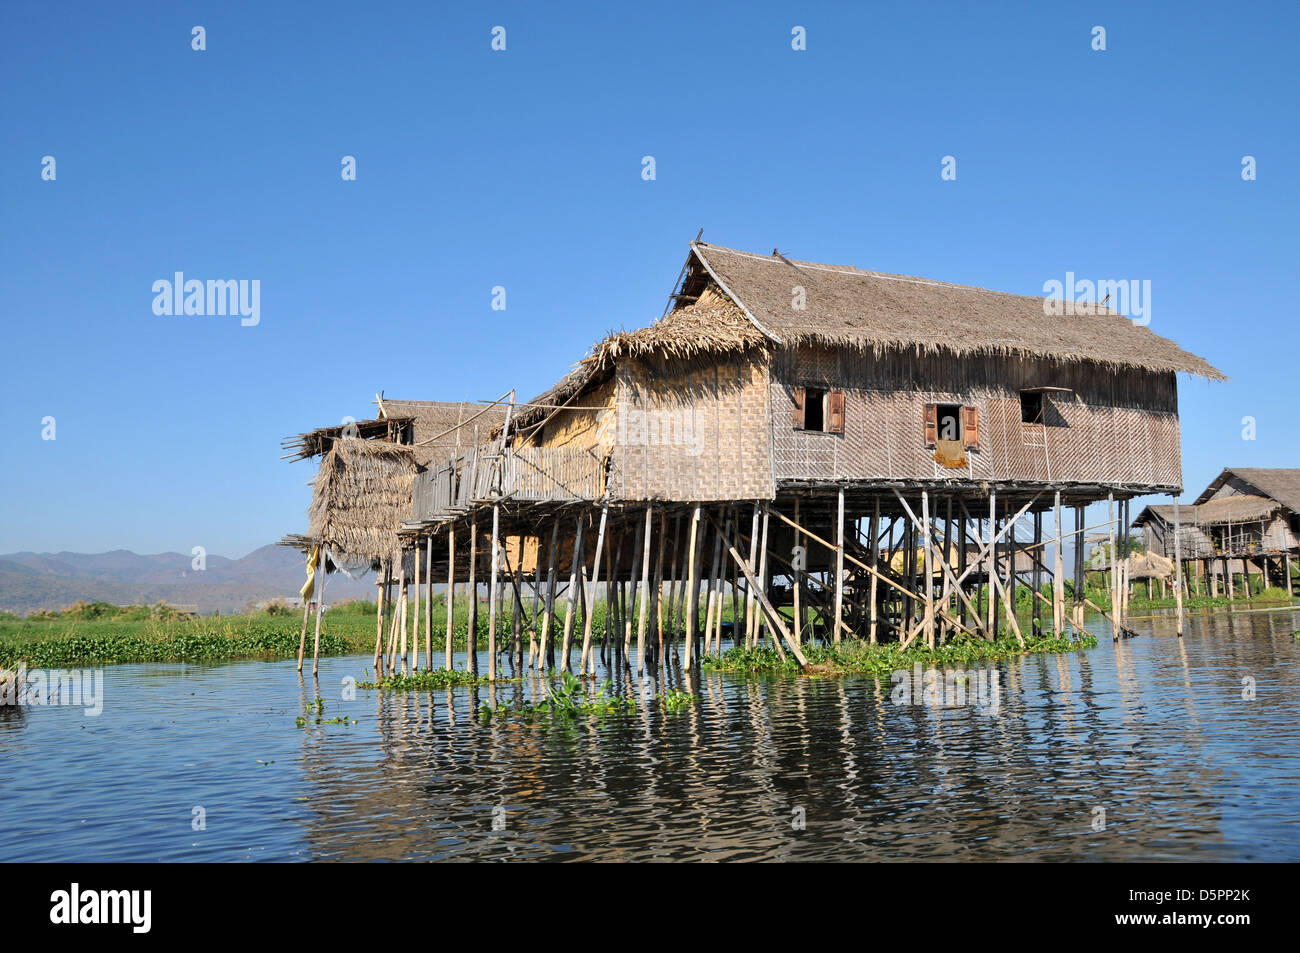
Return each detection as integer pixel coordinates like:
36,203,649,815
770,348,1182,486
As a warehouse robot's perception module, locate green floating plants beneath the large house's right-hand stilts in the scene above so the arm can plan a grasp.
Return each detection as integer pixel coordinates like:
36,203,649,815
702,634,1097,676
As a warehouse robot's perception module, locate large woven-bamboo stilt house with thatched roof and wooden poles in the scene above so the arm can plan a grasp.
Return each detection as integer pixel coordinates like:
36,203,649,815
390,241,1222,676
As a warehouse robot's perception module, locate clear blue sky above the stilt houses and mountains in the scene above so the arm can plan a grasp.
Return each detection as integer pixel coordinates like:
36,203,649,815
0,0,1300,556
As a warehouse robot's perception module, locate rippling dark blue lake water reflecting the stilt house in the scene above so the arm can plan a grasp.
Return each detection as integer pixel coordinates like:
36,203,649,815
0,611,1300,861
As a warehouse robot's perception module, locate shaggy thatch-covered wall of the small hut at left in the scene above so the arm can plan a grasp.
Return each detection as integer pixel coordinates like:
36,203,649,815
307,437,416,566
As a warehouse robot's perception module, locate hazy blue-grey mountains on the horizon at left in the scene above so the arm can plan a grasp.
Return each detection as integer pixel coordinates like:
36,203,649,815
0,545,374,615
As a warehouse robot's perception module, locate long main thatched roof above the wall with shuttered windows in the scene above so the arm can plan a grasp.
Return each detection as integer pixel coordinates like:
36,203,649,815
679,242,1223,380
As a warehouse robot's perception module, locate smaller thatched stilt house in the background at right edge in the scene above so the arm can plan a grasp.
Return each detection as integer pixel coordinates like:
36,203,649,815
1134,467,1300,598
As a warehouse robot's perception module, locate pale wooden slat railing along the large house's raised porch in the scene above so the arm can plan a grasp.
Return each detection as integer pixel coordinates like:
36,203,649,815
413,441,607,520
